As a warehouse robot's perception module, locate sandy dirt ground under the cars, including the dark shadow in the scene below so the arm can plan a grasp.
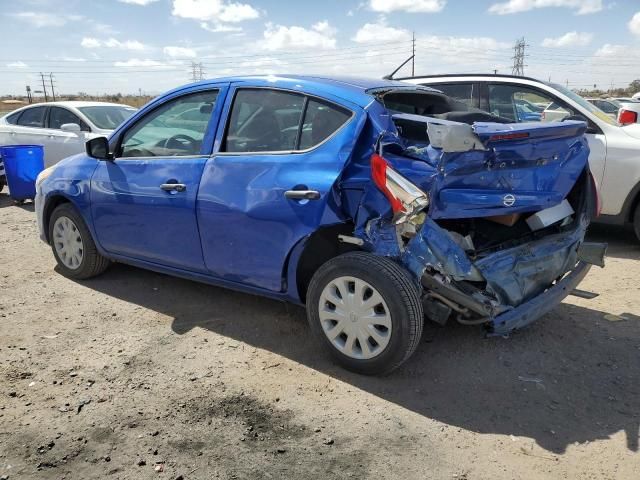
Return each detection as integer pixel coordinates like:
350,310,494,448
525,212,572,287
0,194,640,480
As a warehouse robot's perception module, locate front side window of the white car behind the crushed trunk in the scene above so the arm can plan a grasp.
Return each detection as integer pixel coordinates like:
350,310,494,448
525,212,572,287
489,84,575,122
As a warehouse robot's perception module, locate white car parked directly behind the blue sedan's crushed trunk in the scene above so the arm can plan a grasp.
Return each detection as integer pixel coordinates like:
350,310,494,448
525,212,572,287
399,74,640,239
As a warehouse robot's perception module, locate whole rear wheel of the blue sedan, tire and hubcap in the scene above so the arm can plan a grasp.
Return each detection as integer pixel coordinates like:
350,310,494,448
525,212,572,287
307,252,424,375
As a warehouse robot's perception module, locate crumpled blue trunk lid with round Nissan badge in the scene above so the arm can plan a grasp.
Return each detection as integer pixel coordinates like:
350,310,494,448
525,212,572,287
394,114,589,222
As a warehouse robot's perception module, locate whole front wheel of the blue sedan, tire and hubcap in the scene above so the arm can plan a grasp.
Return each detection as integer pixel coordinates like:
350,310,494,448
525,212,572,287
49,203,110,280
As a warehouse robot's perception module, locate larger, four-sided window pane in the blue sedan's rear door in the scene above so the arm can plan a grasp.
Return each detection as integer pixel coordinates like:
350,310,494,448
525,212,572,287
223,88,305,153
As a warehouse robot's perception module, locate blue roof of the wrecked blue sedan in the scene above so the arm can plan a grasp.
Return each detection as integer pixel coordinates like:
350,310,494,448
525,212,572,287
163,74,438,107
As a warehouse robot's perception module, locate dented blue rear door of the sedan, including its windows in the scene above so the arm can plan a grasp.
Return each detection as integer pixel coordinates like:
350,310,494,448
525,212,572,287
198,88,365,291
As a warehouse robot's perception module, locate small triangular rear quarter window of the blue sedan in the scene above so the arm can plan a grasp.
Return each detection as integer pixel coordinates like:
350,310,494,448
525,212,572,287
298,99,351,150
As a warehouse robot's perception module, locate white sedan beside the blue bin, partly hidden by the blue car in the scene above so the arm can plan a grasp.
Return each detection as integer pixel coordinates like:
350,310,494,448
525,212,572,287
0,101,137,167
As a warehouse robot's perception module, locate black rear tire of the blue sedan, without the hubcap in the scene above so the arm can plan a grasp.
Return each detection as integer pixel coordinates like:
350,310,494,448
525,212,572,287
307,252,424,375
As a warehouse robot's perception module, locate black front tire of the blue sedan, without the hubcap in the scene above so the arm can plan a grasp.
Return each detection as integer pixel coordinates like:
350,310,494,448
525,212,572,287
49,203,111,280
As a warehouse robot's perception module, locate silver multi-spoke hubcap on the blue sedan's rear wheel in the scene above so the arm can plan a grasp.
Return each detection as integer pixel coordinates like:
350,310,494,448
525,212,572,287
318,277,391,360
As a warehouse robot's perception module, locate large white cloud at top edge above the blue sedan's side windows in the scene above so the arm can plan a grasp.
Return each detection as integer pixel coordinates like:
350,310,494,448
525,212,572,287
171,0,260,23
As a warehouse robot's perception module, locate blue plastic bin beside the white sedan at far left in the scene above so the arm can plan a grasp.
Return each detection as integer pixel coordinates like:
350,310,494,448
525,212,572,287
0,145,44,202
